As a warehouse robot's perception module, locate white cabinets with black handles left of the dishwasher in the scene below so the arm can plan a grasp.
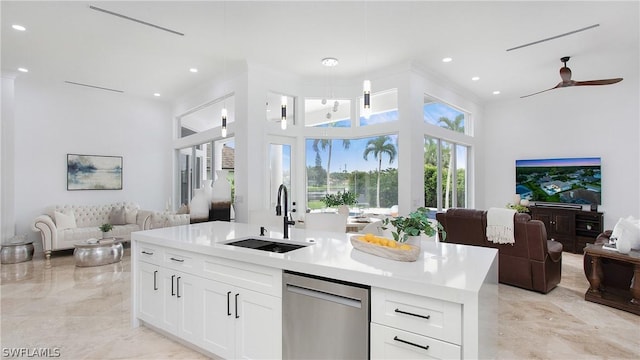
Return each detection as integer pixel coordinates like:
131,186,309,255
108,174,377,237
134,242,282,359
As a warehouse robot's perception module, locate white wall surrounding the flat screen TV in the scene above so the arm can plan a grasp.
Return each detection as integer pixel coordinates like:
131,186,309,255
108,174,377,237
478,75,640,229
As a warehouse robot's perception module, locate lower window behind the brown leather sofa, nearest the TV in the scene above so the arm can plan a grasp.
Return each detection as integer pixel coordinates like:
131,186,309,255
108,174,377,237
424,136,468,210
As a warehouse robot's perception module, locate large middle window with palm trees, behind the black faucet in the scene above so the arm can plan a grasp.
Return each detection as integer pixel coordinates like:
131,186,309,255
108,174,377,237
305,134,398,213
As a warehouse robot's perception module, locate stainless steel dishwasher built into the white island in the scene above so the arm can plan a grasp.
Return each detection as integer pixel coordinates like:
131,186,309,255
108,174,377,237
282,272,370,359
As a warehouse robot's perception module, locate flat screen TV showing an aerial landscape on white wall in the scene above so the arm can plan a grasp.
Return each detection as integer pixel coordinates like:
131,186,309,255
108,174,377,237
516,157,602,205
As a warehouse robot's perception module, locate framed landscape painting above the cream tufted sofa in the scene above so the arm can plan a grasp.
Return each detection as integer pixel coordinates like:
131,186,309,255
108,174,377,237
67,154,122,191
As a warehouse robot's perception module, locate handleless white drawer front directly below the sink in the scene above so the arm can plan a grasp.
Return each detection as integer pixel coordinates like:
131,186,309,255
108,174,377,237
203,257,282,298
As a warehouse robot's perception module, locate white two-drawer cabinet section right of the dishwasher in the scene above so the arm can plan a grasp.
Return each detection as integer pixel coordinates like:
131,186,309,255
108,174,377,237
371,288,462,359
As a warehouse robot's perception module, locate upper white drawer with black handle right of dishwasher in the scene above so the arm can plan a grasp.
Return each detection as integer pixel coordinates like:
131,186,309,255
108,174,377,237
371,288,462,345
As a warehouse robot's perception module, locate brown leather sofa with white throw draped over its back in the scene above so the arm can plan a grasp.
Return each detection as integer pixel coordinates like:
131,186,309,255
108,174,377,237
436,208,562,294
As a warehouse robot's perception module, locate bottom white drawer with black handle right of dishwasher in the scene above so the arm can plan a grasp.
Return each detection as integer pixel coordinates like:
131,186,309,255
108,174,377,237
370,323,462,359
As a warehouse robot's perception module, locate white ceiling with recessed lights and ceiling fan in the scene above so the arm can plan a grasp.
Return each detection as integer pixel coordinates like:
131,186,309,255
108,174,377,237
1,1,640,101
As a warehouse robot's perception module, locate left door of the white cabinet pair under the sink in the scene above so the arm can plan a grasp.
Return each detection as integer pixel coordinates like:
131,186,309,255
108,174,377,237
200,280,237,359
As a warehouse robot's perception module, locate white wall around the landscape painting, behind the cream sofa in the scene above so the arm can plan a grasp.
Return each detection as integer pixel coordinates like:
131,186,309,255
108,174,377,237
13,77,173,247
